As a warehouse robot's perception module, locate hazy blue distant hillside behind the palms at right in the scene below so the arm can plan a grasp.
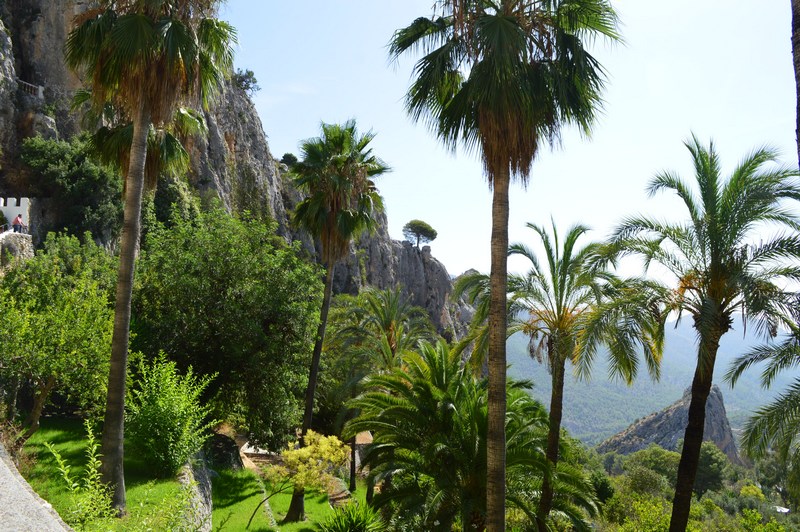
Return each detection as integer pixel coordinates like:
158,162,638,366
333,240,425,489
508,319,800,445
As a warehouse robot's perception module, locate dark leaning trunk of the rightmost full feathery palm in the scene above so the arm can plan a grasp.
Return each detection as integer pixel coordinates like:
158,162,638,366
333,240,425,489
669,338,719,532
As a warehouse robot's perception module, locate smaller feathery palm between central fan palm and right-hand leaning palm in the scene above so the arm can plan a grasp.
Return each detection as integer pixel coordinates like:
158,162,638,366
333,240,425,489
509,223,664,531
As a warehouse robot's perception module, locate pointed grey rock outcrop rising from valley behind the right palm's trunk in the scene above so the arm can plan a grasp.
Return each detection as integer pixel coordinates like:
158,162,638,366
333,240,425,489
597,385,742,465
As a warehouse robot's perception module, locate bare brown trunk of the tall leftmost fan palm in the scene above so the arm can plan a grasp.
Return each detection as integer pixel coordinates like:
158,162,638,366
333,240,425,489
101,102,150,515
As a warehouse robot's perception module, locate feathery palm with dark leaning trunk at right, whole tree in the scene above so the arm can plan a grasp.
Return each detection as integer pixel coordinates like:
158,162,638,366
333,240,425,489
614,136,800,531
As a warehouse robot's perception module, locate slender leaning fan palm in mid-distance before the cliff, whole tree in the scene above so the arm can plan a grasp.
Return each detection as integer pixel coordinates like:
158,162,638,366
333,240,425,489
285,120,389,522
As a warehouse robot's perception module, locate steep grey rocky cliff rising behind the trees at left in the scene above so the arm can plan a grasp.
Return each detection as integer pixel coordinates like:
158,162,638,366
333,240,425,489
0,0,466,335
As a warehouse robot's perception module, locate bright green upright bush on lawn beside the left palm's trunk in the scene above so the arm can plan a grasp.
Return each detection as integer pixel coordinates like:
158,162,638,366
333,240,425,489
127,354,214,477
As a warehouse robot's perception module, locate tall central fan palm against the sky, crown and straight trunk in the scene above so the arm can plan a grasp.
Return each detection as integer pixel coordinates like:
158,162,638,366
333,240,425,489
389,4,617,531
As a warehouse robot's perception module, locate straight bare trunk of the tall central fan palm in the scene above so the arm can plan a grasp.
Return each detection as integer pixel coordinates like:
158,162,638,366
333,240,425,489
486,165,510,532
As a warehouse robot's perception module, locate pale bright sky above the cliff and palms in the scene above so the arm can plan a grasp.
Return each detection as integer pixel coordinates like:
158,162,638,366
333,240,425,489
220,0,797,275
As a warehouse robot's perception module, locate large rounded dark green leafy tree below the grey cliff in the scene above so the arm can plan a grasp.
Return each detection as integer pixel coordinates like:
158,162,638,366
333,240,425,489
134,210,322,449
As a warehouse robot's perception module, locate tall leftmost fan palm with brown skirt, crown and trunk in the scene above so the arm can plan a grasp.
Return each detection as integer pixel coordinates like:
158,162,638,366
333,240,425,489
64,0,235,513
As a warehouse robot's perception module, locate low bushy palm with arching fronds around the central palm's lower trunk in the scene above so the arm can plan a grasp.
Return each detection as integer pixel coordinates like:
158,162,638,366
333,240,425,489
345,341,595,531
